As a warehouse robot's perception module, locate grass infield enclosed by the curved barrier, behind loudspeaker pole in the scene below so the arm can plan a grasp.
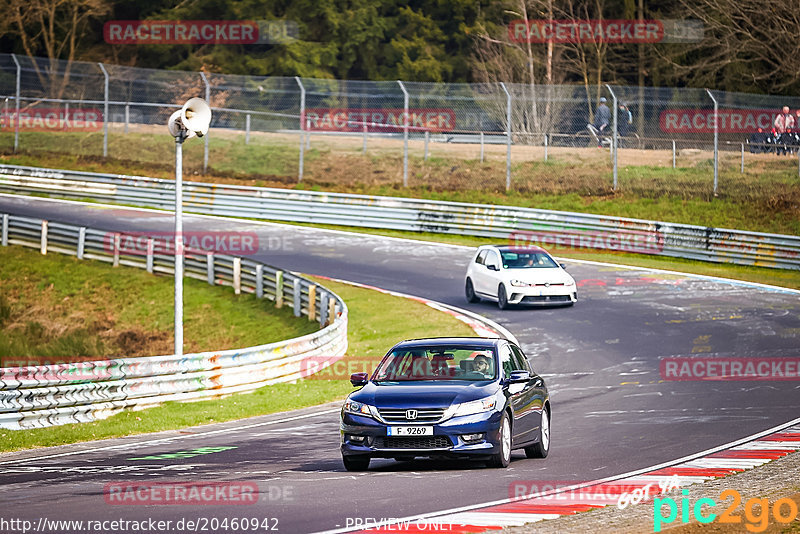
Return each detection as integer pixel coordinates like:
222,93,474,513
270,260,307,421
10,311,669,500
0,246,318,366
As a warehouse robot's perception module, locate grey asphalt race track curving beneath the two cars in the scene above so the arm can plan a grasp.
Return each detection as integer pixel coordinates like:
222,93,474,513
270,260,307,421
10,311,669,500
0,196,800,533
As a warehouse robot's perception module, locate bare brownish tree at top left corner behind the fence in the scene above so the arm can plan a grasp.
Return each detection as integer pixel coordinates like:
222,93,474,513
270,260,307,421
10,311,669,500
0,0,110,98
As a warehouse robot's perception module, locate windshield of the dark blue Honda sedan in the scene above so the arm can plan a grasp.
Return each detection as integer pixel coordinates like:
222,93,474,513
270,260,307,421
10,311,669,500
373,346,497,382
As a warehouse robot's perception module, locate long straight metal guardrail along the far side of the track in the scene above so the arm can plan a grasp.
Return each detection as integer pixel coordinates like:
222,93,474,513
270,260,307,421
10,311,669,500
0,165,800,269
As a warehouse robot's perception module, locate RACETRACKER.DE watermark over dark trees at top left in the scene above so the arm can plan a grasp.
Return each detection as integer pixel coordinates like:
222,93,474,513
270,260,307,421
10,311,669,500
103,20,299,45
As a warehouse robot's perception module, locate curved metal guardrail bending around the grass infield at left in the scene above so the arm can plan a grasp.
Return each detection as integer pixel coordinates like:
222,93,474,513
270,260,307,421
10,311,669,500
0,214,347,430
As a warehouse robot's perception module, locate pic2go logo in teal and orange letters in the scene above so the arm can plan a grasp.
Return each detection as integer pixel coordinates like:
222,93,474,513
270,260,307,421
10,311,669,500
653,489,797,532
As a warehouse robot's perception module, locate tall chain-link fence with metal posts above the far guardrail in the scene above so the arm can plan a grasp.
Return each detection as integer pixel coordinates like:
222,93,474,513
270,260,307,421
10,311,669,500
0,54,800,203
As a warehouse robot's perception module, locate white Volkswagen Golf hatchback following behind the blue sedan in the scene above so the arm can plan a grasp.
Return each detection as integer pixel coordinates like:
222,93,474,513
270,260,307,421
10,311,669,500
464,245,578,309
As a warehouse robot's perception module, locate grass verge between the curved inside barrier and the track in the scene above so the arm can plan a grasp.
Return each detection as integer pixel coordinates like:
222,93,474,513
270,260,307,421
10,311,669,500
0,274,475,451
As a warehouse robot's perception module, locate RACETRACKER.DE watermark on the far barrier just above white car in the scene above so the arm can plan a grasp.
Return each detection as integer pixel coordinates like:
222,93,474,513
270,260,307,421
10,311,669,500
509,230,664,254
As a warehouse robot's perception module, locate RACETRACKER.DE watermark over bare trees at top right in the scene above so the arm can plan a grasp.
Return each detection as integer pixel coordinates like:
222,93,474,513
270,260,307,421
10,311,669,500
508,19,703,43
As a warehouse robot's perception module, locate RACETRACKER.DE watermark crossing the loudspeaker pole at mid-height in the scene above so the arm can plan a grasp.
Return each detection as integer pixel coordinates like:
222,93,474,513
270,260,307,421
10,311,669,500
103,231,280,256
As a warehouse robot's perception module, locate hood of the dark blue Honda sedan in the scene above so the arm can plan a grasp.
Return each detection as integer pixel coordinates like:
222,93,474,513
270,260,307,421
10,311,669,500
350,381,500,409
